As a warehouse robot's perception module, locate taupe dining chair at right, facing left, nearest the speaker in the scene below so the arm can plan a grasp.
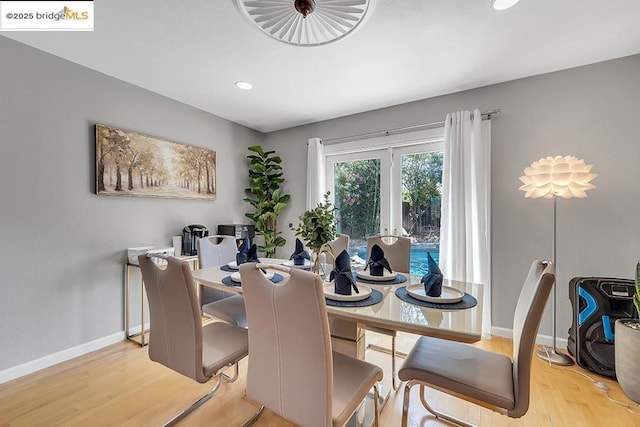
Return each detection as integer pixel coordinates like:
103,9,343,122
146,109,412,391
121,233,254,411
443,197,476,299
398,261,555,426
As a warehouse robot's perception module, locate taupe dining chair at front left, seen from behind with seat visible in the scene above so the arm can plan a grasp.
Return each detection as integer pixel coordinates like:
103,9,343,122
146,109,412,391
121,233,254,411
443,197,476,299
138,254,249,426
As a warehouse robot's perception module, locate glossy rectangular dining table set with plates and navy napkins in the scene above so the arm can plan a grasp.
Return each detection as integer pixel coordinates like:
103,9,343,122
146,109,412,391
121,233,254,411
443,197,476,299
192,258,484,427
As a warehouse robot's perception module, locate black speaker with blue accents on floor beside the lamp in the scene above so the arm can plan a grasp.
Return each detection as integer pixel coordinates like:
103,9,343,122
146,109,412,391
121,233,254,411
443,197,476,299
567,277,636,378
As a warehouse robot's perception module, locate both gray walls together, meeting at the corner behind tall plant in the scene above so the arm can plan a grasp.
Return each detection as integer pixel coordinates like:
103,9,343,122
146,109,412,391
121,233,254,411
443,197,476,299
0,32,640,371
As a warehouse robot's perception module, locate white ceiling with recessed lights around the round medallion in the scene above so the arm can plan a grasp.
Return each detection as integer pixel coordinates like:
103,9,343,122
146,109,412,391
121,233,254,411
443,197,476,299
3,0,640,132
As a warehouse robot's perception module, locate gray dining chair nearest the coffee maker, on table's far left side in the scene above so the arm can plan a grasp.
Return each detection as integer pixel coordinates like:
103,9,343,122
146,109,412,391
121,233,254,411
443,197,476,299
198,236,247,327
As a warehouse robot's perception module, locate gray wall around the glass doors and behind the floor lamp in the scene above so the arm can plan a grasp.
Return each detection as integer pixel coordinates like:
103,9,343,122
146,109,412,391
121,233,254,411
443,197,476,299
265,56,640,337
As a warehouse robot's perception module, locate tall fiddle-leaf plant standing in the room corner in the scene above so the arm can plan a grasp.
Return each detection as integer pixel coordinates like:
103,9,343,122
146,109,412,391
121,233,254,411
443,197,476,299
244,145,291,258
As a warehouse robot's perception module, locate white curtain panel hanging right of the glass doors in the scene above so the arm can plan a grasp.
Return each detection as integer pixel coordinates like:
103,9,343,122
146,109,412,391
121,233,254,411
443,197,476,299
440,109,491,337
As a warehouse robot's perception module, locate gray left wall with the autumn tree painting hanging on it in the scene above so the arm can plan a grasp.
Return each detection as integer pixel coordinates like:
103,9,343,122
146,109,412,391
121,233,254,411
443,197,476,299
0,37,263,371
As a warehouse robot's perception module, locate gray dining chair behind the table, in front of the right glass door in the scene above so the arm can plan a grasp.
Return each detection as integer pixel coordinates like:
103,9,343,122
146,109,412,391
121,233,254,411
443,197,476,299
366,236,411,390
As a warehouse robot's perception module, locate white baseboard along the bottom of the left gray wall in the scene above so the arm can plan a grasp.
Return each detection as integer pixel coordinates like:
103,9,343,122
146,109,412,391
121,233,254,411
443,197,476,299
0,327,124,384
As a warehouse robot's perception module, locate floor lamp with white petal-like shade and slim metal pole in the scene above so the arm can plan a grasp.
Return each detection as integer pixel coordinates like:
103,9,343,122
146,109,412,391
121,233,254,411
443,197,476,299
520,156,598,365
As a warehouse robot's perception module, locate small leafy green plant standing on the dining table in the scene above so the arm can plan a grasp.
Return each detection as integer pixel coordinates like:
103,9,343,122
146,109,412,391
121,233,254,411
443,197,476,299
296,191,336,272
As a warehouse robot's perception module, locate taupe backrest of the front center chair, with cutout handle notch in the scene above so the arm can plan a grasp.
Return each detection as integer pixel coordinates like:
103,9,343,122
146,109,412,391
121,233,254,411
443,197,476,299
240,263,333,426
